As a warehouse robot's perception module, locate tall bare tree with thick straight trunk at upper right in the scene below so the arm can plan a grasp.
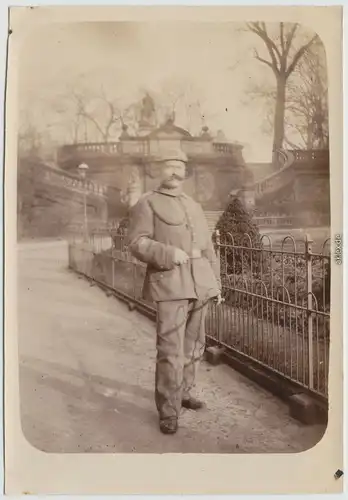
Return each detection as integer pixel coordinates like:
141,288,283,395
247,22,318,163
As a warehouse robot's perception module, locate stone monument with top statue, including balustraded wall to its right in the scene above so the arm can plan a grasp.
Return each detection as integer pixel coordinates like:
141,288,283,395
57,100,330,232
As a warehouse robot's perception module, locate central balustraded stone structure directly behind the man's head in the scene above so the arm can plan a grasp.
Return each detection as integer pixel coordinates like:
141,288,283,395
58,119,252,219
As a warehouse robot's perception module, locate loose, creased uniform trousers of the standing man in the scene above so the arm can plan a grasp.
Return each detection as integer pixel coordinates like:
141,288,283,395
155,300,208,419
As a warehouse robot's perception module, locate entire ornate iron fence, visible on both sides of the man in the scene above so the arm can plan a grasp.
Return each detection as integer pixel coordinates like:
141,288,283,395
69,229,331,398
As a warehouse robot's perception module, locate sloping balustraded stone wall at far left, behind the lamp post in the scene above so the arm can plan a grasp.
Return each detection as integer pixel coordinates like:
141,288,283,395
17,159,108,239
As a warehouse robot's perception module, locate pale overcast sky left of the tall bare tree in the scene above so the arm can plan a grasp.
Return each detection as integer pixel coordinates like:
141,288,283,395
19,22,320,161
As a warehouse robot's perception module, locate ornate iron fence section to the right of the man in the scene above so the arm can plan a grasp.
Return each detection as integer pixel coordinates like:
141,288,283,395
211,230,331,396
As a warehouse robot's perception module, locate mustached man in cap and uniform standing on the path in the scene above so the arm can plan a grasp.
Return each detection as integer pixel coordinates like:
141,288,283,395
128,150,221,434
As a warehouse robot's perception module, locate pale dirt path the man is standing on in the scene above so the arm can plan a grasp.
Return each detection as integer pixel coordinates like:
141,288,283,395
18,242,324,453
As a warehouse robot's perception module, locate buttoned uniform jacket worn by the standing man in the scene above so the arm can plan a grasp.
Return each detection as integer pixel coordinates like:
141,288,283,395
128,188,221,302
